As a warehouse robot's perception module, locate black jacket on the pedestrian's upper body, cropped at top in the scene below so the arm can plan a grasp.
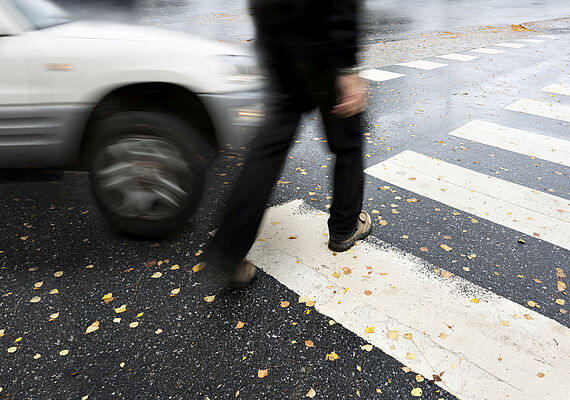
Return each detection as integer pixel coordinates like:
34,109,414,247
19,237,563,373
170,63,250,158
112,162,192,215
250,0,359,68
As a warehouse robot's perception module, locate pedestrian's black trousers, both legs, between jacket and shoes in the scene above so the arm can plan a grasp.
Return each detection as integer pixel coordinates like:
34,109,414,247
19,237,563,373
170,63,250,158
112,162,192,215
205,45,363,272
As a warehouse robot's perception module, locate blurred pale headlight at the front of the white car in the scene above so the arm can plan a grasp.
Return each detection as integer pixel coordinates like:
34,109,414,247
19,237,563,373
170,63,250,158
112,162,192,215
210,55,263,83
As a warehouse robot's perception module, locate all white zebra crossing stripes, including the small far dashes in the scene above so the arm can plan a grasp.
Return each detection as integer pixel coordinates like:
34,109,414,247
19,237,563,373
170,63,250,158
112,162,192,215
248,36,570,400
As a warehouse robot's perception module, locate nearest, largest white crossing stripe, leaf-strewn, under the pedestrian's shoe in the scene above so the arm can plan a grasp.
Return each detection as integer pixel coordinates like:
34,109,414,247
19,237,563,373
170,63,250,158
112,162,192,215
248,200,570,400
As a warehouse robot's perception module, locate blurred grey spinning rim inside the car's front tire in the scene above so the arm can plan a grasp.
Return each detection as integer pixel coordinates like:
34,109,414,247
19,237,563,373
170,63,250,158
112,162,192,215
93,136,194,220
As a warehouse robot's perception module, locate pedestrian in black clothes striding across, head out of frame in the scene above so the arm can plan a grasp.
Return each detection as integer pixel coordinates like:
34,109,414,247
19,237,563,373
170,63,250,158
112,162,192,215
205,0,372,287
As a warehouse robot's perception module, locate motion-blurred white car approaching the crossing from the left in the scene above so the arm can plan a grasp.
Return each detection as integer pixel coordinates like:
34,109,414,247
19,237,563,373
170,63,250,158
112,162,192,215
0,0,264,236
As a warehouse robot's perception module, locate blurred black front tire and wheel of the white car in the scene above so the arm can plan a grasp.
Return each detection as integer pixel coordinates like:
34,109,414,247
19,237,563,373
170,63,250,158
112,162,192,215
88,111,211,237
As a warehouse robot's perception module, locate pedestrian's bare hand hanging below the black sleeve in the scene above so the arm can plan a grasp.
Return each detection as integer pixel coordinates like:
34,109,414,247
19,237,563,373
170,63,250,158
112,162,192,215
332,74,366,118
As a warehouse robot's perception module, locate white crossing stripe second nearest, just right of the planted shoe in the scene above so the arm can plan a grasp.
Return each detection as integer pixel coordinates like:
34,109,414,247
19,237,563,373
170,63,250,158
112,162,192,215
364,150,570,250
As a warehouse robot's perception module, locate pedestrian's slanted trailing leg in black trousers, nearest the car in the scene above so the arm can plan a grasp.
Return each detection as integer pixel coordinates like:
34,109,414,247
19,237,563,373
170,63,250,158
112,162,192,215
205,109,300,275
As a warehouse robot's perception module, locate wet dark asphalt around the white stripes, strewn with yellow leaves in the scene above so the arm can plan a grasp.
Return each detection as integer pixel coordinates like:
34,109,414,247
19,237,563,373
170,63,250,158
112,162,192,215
0,3,570,399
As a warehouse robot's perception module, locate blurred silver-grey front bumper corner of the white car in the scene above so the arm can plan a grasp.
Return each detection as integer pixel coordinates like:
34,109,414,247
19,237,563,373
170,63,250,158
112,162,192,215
199,90,267,148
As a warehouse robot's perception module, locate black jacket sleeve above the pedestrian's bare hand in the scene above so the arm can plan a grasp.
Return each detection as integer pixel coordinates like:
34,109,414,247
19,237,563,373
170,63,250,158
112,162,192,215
323,0,360,68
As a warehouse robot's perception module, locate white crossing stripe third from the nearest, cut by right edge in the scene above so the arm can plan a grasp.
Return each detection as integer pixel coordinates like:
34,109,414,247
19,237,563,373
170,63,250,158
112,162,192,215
449,120,570,166
